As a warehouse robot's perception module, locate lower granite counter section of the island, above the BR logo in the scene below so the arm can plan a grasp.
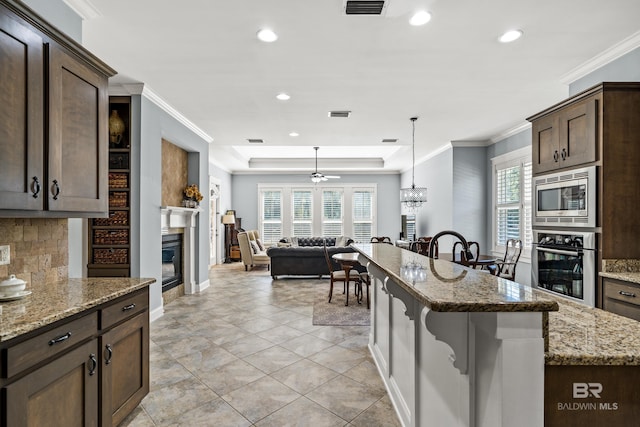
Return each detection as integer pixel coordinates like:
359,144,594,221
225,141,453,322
538,291,640,365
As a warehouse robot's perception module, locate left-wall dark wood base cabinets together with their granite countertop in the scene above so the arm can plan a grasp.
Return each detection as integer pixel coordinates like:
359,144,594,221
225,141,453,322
0,278,155,426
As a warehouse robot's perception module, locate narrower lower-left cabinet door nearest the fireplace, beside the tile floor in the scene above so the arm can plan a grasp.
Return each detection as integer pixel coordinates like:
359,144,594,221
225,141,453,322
100,312,149,426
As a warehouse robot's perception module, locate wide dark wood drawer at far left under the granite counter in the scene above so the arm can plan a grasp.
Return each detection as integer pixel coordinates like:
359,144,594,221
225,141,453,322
4,313,98,378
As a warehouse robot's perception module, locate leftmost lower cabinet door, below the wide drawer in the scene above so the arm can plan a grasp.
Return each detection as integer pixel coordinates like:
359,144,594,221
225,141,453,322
3,339,99,427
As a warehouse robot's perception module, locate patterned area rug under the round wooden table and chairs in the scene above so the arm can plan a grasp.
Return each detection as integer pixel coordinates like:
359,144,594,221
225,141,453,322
313,291,371,326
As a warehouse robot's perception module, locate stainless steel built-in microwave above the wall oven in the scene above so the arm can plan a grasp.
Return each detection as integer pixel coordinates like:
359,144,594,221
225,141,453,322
533,166,598,227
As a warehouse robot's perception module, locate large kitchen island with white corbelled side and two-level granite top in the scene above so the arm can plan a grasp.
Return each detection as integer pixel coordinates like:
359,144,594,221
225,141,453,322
355,244,640,427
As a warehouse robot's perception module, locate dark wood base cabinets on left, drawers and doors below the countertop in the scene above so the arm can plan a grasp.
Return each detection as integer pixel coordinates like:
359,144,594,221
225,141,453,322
0,288,149,427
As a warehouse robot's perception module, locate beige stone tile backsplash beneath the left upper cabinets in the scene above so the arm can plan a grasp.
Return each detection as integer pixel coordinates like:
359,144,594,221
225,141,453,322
0,218,69,288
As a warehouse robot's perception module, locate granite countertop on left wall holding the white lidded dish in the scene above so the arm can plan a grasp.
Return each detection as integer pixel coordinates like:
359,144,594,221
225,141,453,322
0,277,156,342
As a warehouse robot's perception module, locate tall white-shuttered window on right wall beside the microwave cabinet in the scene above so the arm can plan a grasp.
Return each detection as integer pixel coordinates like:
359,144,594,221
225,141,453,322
492,149,532,252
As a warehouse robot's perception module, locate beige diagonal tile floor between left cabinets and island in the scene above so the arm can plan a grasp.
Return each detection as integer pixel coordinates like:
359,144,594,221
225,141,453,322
121,263,400,427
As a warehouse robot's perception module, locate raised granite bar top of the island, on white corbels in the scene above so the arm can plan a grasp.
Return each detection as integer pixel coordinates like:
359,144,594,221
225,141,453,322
352,243,558,312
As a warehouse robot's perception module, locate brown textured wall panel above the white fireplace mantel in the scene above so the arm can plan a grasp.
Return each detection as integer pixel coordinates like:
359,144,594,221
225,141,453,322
162,139,188,206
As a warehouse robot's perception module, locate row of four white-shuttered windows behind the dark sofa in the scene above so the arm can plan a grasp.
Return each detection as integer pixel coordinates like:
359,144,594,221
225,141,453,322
258,183,377,244
